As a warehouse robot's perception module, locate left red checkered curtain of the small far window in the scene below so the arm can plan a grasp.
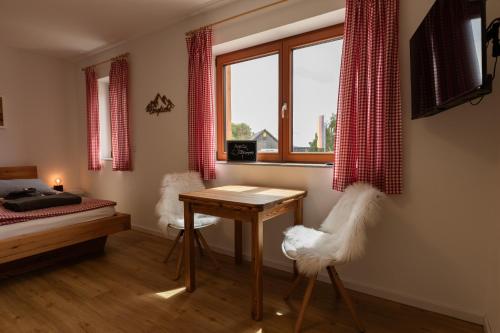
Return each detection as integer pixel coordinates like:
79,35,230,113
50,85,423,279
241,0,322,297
85,67,101,171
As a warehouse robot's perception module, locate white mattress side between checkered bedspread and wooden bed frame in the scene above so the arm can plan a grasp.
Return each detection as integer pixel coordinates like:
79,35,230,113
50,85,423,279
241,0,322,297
0,206,115,240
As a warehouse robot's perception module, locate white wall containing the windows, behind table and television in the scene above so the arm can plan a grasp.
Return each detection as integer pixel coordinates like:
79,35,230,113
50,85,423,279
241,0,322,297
74,0,500,322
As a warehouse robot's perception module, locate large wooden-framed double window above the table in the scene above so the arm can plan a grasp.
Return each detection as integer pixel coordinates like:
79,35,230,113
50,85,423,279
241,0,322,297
216,25,344,163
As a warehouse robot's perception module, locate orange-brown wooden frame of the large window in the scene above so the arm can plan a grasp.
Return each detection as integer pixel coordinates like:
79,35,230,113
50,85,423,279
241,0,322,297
215,24,344,163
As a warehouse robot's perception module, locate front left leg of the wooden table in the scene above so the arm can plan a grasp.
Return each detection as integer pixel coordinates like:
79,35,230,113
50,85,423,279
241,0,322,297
184,202,196,292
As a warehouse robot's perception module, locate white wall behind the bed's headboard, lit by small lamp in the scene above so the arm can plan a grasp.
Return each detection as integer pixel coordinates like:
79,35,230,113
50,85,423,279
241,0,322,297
0,47,80,187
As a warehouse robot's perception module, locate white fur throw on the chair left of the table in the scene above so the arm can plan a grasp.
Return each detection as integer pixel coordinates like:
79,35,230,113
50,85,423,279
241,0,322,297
156,172,219,235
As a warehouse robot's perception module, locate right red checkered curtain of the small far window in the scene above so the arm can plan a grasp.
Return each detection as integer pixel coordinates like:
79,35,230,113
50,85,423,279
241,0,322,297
109,58,132,171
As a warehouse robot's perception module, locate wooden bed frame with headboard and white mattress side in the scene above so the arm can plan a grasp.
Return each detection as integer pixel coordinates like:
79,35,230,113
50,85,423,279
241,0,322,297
0,166,130,277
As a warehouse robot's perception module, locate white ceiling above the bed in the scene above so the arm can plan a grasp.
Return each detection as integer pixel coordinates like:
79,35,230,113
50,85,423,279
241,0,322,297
0,0,227,59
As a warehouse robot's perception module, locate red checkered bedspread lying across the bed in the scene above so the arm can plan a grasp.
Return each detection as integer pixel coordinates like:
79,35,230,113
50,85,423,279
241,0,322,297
0,198,116,226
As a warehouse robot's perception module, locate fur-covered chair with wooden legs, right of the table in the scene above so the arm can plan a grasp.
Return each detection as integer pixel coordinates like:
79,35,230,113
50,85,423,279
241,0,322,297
282,183,384,332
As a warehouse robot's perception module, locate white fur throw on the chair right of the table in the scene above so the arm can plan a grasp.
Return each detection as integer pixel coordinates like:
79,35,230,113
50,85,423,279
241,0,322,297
282,183,384,276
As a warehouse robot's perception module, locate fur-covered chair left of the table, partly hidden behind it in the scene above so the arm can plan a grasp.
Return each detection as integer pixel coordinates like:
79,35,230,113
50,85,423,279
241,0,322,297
156,172,220,280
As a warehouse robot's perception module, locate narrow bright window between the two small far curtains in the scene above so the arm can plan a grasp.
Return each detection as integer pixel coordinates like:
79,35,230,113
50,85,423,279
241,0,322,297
97,76,112,160
